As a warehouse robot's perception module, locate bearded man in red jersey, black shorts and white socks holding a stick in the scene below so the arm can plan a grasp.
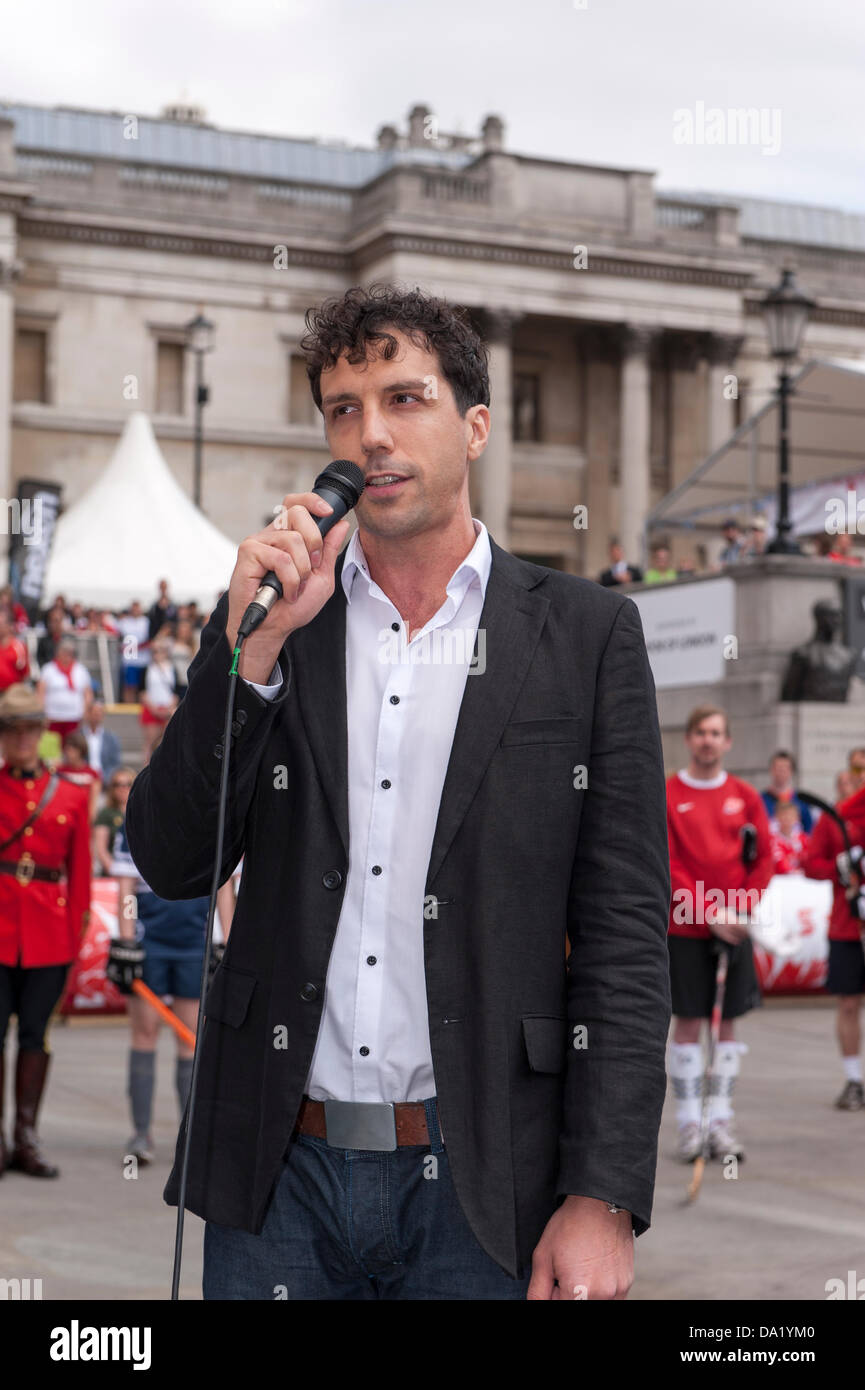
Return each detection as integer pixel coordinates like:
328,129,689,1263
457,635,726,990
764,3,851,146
666,705,772,1163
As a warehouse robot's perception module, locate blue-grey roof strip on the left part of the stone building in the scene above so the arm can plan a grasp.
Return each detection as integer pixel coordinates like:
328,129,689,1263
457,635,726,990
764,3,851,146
0,103,473,188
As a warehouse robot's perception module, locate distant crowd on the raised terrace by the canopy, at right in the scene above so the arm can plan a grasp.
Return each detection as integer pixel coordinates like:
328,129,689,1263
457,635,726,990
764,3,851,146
598,516,864,588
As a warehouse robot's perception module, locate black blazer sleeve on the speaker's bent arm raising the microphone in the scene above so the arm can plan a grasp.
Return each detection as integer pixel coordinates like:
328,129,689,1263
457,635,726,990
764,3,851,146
127,594,291,899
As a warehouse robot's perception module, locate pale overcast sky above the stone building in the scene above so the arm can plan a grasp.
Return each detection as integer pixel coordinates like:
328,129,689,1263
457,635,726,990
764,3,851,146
0,0,865,213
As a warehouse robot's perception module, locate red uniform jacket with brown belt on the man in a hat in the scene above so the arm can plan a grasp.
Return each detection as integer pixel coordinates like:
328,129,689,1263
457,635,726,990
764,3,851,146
0,767,90,969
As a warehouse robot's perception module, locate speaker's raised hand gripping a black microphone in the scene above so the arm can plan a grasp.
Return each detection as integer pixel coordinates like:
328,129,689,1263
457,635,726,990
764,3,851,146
225,459,364,682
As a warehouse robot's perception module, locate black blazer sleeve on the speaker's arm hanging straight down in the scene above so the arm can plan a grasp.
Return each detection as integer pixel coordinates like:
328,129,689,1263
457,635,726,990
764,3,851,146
558,599,670,1234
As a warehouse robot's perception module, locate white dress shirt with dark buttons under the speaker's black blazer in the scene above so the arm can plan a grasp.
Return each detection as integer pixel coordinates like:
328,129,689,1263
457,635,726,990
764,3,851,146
249,518,492,1101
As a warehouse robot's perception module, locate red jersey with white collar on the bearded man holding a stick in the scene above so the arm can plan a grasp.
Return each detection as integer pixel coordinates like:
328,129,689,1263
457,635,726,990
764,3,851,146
666,773,773,938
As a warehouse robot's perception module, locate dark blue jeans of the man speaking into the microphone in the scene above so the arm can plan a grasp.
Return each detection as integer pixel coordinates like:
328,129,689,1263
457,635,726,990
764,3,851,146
203,1102,528,1301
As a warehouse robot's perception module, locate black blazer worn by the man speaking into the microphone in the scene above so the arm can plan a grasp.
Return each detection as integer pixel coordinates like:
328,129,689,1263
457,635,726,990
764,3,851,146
127,538,670,1275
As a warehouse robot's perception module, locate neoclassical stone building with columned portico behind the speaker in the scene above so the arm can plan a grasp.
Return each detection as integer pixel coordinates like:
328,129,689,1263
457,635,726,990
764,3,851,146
0,96,865,574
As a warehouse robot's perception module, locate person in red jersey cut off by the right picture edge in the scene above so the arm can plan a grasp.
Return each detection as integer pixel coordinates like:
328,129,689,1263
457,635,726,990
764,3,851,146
802,748,865,1111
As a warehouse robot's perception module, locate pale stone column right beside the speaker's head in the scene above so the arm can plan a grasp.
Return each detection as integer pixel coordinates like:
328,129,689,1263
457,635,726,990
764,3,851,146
481,309,522,550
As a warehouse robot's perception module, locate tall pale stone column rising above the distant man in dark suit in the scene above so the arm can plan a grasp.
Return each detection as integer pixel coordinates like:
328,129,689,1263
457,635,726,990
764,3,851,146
619,324,655,564
